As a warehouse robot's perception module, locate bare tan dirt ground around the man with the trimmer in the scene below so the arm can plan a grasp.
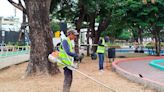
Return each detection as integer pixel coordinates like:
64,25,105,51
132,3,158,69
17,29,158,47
0,58,156,92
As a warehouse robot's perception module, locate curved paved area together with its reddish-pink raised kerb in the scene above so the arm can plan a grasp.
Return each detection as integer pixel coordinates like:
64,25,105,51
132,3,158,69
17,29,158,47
112,56,164,92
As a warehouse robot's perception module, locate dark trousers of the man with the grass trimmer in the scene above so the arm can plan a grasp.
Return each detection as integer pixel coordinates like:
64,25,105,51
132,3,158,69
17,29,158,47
63,67,73,92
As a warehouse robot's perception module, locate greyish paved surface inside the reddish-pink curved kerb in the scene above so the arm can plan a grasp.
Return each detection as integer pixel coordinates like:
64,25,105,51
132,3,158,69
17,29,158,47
118,60,164,84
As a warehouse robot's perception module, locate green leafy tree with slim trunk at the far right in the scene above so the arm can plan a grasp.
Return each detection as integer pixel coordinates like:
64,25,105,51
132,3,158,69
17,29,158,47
123,0,164,56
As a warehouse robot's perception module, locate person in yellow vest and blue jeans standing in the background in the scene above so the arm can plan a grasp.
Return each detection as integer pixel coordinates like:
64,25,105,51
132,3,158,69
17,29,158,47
96,37,109,72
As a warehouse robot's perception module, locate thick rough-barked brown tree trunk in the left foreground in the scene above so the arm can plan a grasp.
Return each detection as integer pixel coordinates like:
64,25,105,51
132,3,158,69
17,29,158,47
25,0,59,75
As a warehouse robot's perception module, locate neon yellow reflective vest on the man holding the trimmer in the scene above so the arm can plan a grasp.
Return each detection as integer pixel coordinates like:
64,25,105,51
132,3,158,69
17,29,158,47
58,38,73,67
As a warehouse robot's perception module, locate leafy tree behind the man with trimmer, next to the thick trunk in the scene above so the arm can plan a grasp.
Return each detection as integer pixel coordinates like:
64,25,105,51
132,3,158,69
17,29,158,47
51,0,86,53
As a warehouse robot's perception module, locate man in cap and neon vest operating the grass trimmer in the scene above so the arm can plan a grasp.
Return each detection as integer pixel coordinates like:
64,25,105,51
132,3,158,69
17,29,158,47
59,29,79,92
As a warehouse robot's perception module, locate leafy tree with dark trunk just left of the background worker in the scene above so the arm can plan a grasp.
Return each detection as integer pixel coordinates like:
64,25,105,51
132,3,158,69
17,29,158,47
86,0,116,52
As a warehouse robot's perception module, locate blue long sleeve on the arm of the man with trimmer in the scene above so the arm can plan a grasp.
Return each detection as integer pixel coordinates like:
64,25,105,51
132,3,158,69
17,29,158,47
62,40,77,57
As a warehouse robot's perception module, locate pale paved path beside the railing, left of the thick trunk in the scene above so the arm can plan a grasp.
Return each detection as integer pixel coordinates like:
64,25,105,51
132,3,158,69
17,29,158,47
0,54,29,69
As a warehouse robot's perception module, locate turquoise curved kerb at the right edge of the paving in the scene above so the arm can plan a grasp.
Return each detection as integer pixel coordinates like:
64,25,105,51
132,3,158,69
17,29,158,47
149,59,164,70
